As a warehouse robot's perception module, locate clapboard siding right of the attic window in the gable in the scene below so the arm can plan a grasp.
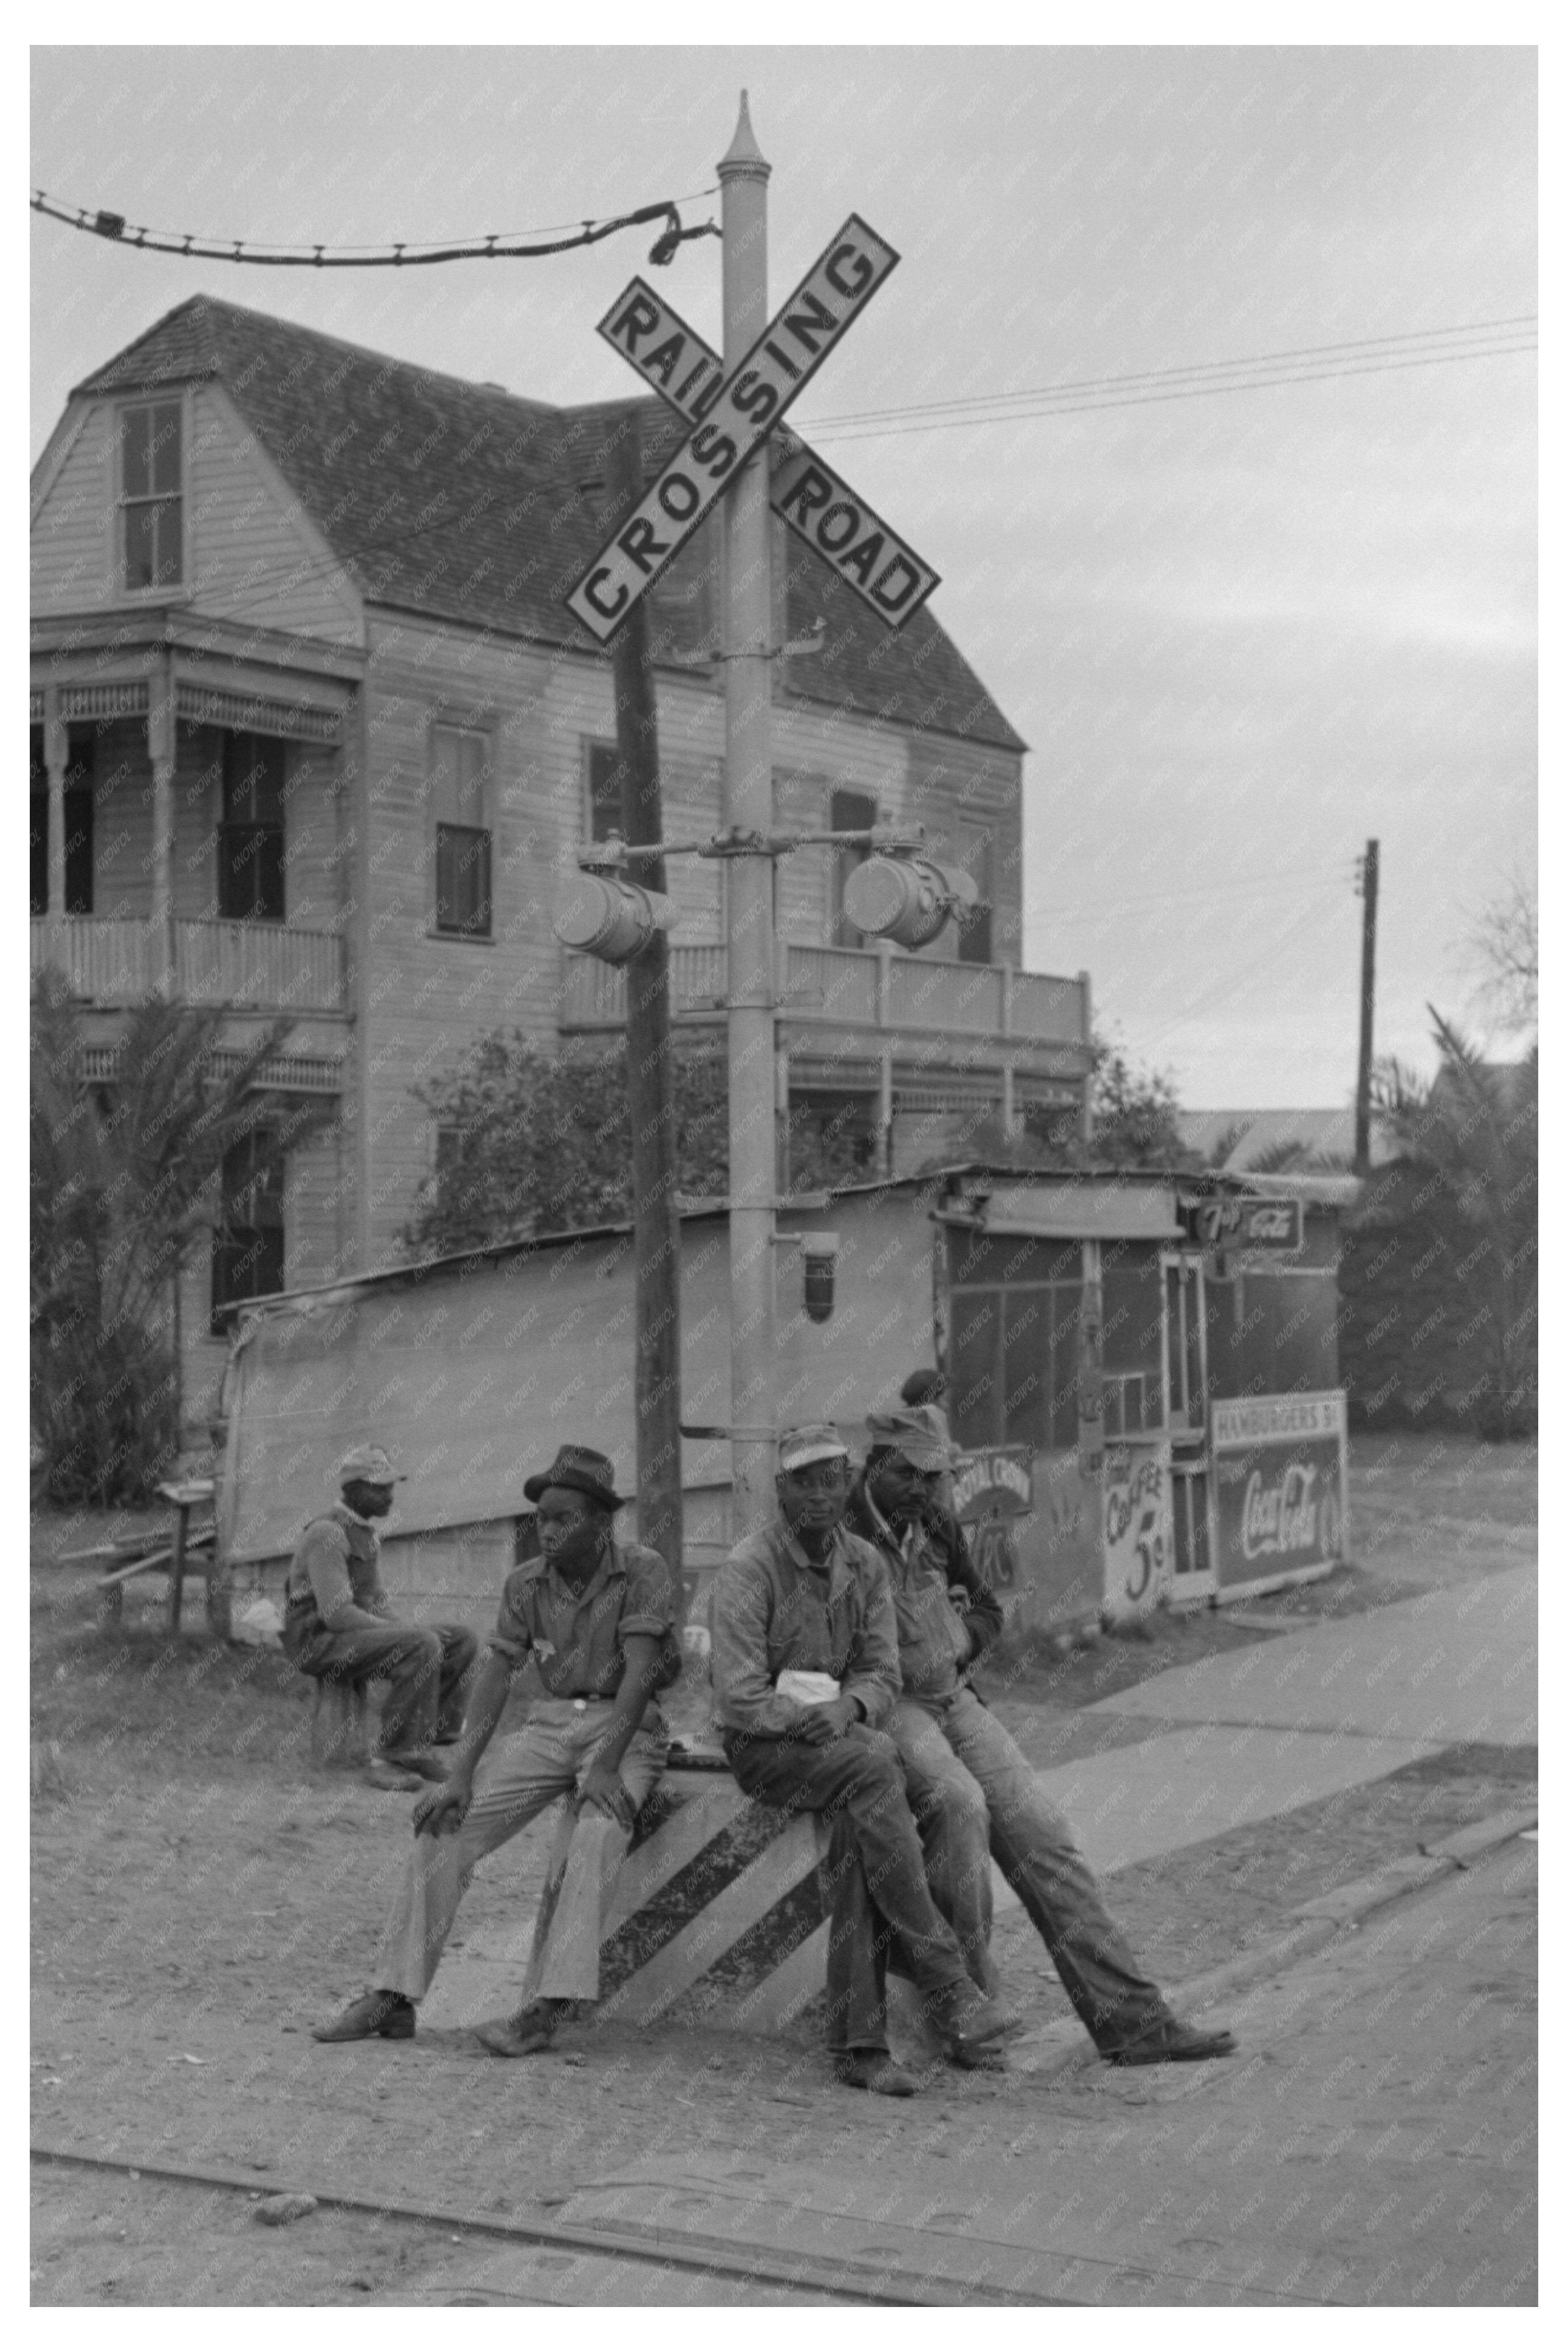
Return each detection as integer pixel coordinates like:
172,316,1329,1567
186,383,365,644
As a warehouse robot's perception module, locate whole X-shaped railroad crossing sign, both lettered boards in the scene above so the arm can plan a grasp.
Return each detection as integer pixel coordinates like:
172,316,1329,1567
566,211,938,644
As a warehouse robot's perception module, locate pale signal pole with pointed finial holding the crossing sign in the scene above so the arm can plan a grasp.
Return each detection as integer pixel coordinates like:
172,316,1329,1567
720,92,778,1541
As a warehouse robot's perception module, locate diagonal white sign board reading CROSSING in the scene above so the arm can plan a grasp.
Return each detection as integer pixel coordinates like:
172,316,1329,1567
566,211,898,644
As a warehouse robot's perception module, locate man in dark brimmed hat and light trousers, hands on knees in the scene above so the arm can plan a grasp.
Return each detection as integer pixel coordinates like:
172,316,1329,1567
315,1446,682,2058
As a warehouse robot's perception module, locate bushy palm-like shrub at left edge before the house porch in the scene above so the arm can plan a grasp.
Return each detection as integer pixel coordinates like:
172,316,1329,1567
28,974,329,1505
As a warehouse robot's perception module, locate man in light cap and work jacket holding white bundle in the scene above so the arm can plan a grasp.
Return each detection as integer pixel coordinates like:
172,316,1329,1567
712,1423,1016,2098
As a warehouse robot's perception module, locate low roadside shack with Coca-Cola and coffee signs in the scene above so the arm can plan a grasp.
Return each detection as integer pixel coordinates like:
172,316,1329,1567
219,1167,1354,1628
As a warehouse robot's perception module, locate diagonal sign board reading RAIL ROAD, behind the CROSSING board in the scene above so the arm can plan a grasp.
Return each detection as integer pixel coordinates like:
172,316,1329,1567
599,278,940,628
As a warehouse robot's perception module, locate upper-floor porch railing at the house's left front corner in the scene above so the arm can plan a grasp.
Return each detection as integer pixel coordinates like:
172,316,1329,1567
30,915,346,1014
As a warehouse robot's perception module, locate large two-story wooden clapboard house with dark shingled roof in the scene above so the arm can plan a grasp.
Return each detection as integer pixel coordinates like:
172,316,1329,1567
30,297,1088,1418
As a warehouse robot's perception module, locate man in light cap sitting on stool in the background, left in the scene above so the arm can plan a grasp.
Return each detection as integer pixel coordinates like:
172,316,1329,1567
282,1446,477,1787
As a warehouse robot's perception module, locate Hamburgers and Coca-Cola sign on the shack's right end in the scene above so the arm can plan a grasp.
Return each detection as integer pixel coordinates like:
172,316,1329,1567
1211,1387,1345,1595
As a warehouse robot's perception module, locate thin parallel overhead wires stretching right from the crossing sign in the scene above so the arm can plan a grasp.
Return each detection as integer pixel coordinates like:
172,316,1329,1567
811,313,1535,442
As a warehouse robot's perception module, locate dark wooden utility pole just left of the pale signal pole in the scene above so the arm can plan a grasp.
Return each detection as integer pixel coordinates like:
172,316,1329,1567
607,409,684,1576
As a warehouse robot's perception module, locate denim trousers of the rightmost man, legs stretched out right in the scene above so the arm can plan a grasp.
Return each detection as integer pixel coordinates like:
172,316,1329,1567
889,1689,1171,2051
